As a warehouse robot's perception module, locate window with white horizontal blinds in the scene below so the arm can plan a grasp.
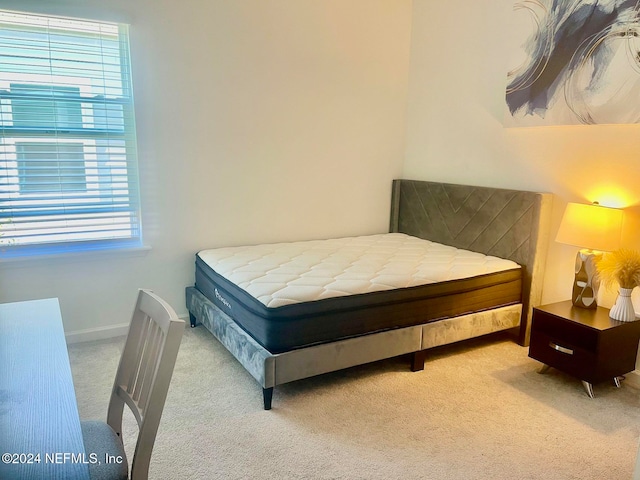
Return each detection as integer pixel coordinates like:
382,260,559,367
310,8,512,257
0,11,142,256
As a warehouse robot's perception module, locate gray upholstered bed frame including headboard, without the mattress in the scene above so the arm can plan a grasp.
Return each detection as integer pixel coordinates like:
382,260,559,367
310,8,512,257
186,180,551,410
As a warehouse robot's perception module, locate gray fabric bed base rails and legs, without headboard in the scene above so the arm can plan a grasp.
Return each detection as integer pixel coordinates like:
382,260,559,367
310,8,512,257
186,287,522,410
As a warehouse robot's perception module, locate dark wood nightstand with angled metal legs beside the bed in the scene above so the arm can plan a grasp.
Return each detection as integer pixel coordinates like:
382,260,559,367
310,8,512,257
529,301,640,398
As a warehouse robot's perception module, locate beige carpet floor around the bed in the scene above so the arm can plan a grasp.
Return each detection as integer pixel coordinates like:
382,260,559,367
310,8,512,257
69,326,640,480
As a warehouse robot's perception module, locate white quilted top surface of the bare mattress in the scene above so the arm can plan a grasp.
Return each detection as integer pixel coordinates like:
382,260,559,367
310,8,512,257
198,233,519,308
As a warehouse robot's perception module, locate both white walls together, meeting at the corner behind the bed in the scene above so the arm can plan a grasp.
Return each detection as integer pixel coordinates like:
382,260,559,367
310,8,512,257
0,0,640,338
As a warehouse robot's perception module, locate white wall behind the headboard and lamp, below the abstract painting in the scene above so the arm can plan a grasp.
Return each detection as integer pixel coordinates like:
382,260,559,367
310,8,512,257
403,0,640,305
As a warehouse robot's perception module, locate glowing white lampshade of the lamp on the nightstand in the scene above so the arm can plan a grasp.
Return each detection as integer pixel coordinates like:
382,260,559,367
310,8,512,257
556,203,622,252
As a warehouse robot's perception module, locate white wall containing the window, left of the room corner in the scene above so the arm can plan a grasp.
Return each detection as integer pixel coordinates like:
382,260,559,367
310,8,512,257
0,0,411,332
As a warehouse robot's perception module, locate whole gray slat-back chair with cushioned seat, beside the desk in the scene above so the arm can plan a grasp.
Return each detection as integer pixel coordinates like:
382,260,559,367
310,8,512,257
81,290,184,480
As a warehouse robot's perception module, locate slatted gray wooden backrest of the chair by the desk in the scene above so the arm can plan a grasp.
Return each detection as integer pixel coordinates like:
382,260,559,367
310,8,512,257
107,290,184,480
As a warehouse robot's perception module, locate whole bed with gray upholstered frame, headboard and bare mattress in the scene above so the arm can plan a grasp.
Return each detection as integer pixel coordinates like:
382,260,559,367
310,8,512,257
186,180,551,410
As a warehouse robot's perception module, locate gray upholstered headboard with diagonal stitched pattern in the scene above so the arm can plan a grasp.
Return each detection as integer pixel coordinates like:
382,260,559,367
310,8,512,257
390,180,552,345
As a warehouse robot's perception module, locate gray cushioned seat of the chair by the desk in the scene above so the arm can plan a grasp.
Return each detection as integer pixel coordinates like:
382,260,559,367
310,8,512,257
80,420,129,480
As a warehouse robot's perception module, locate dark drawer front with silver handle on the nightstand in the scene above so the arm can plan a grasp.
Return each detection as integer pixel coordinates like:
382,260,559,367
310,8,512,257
529,330,597,380
